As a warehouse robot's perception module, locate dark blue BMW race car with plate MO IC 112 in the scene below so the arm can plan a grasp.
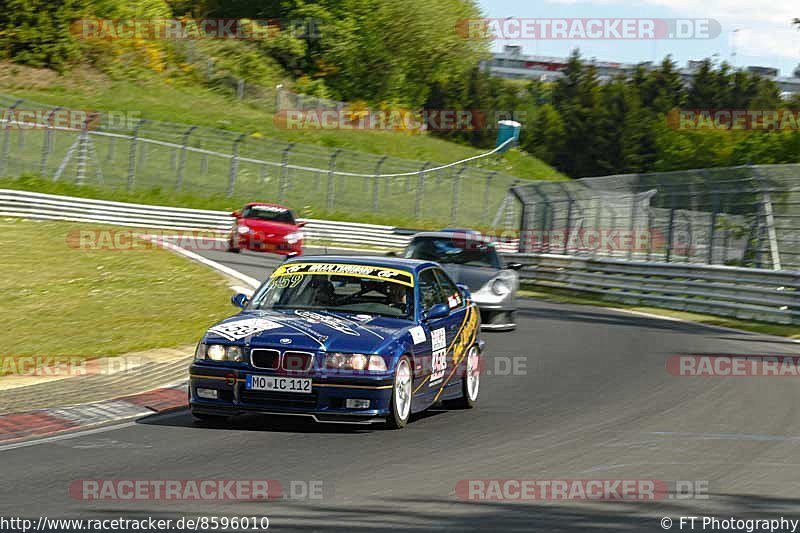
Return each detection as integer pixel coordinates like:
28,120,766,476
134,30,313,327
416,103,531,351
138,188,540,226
189,256,484,428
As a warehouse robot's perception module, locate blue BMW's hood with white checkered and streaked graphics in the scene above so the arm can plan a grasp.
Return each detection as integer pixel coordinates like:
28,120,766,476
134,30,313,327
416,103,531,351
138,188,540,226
205,309,414,353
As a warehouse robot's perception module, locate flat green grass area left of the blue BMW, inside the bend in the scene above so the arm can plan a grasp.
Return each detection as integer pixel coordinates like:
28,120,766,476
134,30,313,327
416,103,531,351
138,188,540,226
0,218,234,358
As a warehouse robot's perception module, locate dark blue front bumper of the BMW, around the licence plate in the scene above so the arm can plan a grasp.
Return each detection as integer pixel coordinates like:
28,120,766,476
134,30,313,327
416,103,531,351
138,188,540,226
189,363,393,424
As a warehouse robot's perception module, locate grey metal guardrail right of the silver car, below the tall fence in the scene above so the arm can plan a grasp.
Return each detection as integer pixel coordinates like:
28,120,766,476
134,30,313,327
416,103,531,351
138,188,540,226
507,253,800,325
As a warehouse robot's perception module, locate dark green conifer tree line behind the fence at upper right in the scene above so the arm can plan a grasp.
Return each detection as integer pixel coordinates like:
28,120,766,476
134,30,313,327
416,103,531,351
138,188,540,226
427,52,800,177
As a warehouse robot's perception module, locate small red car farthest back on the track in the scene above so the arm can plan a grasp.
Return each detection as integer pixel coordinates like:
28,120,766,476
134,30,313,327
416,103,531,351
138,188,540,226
228,202,306,257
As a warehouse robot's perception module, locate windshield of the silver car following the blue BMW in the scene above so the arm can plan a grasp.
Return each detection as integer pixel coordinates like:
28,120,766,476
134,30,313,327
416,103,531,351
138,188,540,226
405,237,501,268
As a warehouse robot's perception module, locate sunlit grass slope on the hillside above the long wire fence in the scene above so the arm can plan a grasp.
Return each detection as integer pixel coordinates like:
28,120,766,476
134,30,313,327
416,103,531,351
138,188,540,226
0,63,567,180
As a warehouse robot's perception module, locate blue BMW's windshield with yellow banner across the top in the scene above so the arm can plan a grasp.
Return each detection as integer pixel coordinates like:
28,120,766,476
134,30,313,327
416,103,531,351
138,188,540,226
248,263,414,319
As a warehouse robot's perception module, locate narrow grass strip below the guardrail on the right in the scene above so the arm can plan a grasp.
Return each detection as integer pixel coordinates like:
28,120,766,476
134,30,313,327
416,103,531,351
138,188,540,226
519,285,800,339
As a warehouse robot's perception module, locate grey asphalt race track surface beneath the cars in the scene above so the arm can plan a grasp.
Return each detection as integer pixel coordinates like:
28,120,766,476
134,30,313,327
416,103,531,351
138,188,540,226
0,247,800,531
